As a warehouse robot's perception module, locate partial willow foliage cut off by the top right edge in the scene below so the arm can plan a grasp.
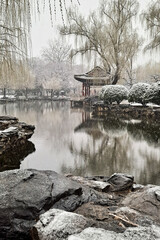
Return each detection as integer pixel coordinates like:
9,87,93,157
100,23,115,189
142,0,160,50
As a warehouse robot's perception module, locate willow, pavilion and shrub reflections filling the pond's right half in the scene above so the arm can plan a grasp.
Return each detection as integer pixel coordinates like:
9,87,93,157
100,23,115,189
62,118,160,183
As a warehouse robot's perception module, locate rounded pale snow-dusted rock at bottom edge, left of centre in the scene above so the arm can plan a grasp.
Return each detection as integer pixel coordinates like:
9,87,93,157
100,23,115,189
32,209,91,240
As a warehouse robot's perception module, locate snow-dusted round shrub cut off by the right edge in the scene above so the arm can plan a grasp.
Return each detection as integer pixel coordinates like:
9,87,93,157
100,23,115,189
144,82,160,105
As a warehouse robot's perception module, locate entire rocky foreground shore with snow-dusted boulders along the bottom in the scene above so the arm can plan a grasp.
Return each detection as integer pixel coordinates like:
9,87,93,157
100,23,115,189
0,169,160,240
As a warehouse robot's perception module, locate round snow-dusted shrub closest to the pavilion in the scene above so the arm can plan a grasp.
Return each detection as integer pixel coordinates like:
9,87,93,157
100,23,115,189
103,85,128,104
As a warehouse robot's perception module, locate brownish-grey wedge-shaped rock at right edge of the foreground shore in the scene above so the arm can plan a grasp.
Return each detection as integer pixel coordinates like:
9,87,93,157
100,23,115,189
122,185,160,223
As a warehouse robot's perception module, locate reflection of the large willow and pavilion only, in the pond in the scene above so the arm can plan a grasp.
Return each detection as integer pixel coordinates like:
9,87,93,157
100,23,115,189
62,119,130,175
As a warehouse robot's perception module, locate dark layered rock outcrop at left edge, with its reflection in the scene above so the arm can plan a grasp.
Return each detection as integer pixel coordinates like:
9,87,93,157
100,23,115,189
0,116,35,171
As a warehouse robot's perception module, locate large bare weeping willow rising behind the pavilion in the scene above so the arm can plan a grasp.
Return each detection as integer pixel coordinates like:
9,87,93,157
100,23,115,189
60,0,140,84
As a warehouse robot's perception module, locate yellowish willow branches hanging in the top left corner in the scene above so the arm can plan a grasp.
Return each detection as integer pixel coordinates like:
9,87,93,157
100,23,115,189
0,0,77,89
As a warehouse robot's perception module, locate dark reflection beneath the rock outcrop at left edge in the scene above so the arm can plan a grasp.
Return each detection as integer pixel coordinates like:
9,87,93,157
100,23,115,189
0,141,35,171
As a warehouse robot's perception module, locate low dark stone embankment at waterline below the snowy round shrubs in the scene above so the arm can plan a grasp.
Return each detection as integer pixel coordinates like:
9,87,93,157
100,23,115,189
92,102,160,119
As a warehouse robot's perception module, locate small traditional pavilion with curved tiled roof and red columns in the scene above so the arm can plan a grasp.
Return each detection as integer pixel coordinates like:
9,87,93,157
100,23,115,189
74,67,111,97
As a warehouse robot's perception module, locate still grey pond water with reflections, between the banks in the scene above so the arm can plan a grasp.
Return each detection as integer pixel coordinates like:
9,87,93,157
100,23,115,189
0,102,160,185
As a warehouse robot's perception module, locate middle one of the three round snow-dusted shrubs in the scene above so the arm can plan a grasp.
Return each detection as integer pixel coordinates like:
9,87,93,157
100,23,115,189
128,83,150,104
